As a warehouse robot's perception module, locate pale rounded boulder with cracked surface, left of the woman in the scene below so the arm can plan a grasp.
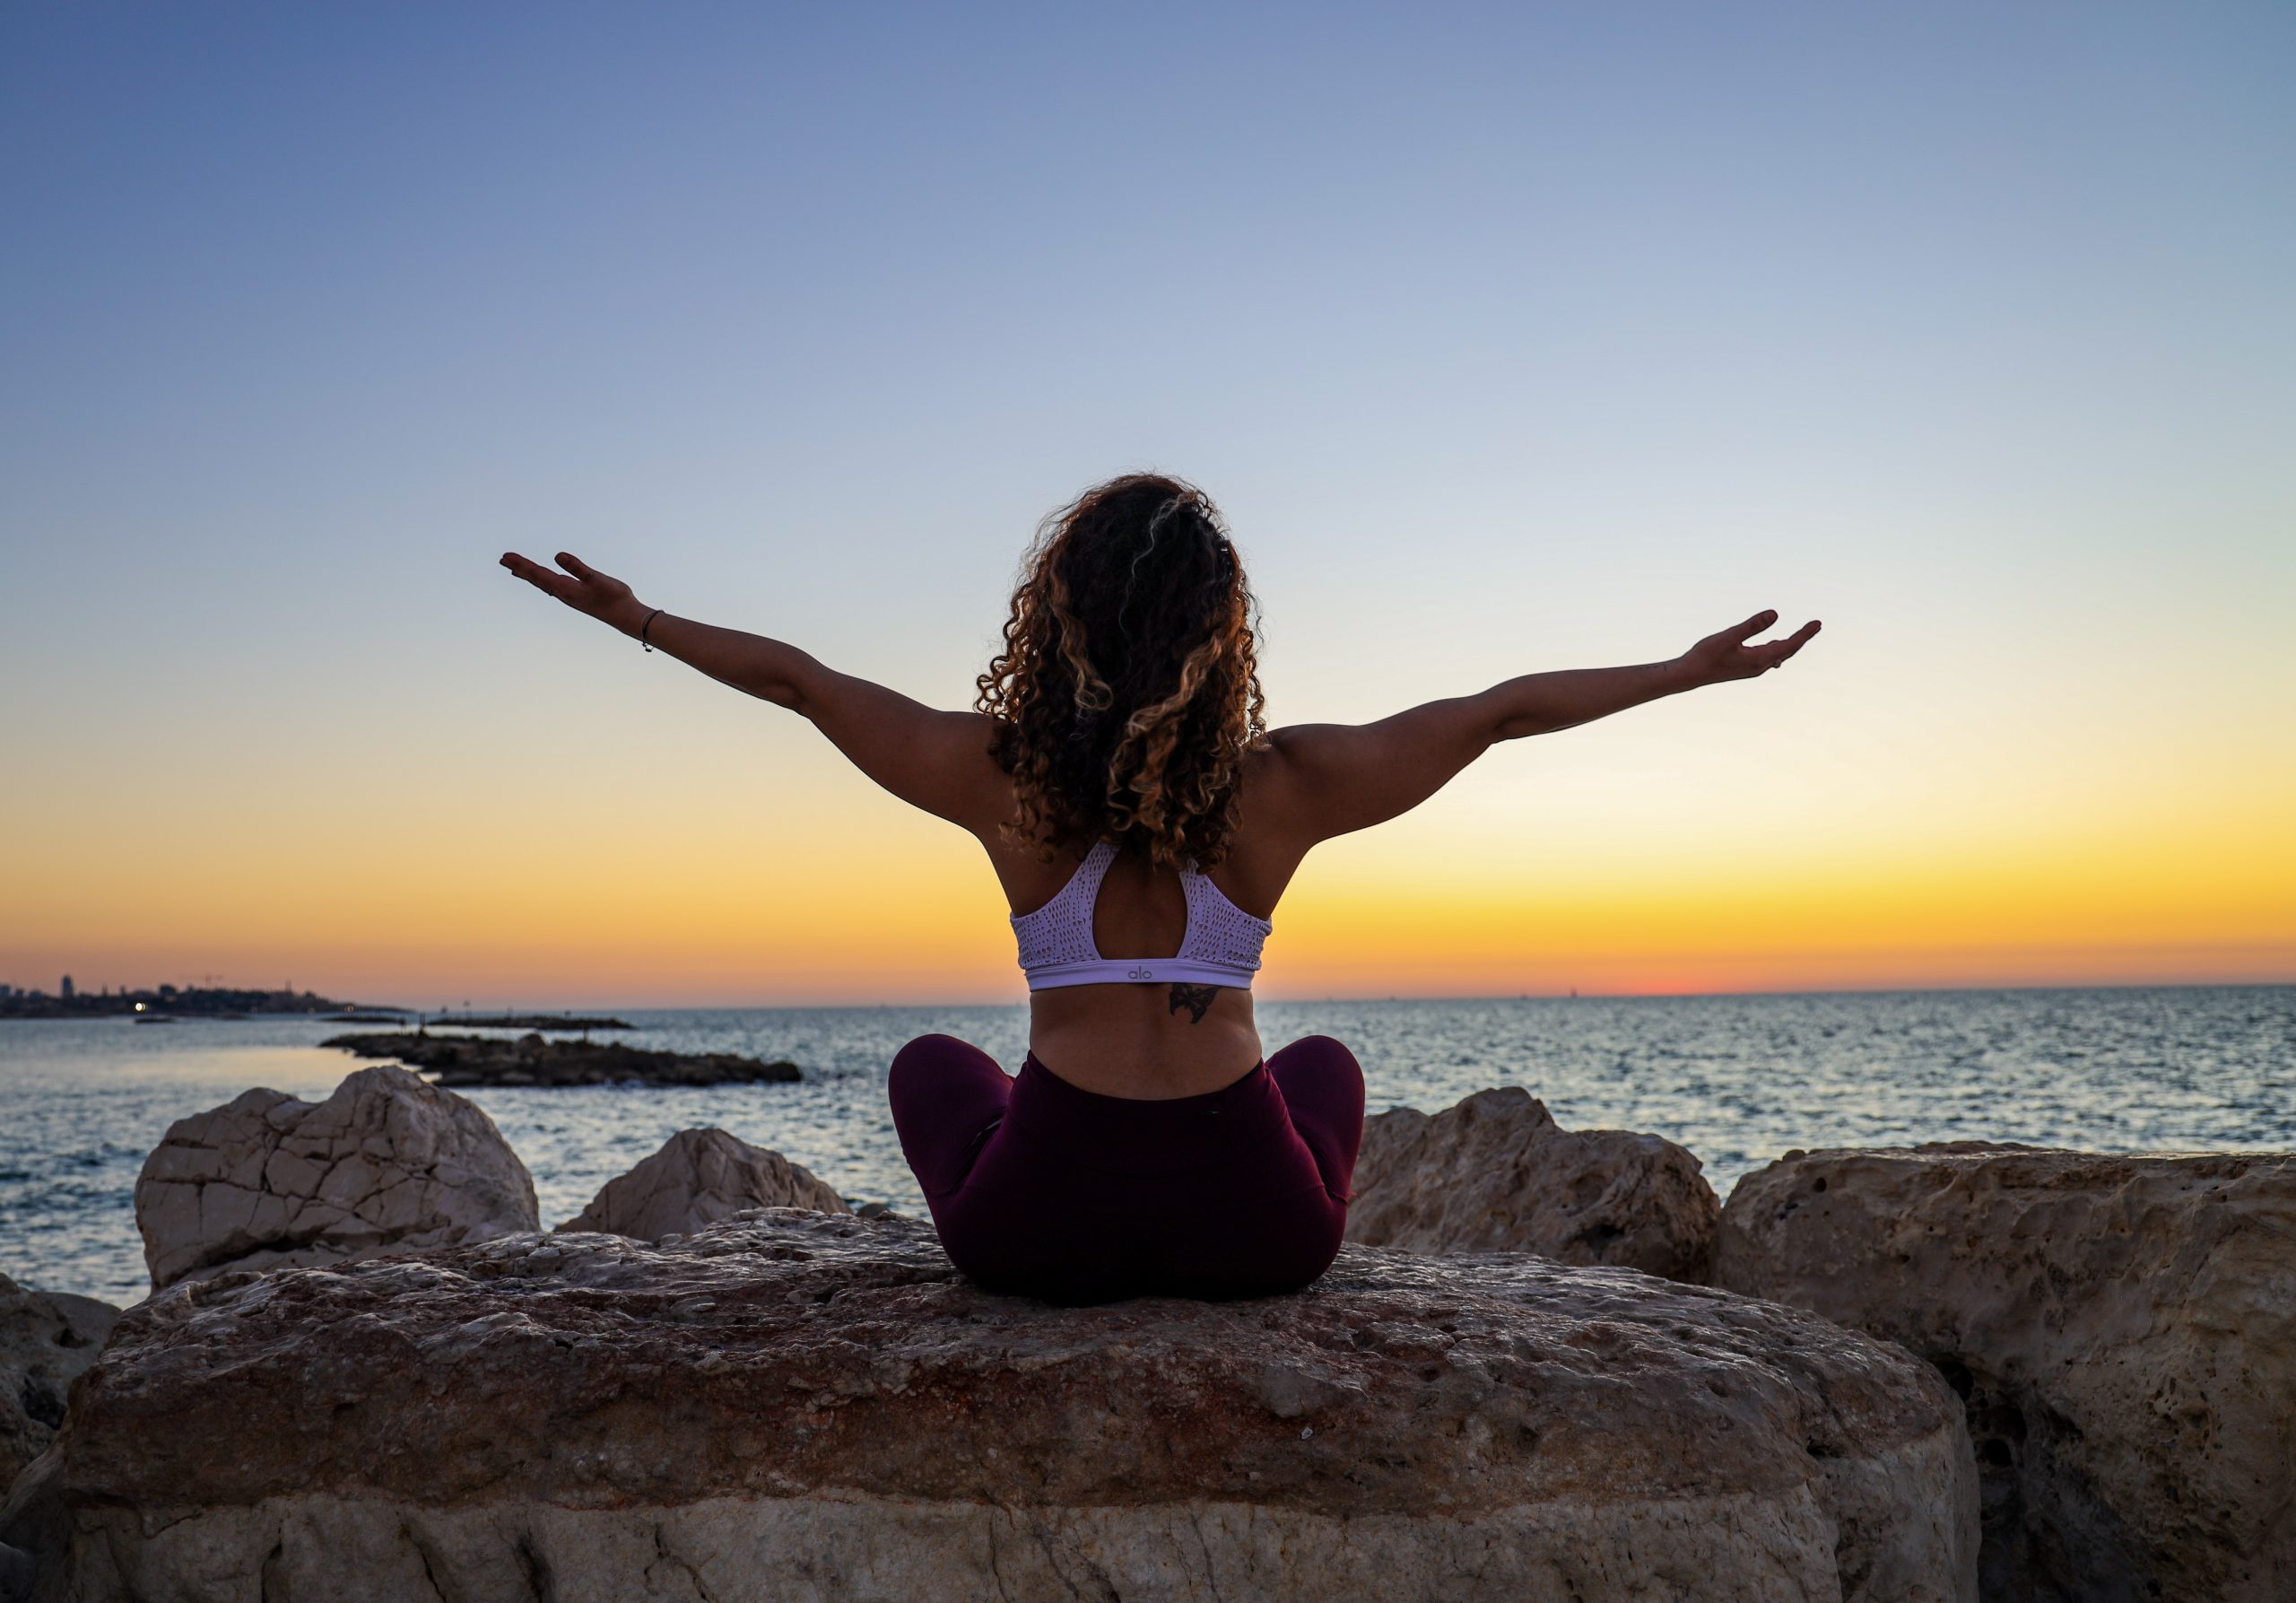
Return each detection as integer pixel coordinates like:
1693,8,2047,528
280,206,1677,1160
135,1067,540,1291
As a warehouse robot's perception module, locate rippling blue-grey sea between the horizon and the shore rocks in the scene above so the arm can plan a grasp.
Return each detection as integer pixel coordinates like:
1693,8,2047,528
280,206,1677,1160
0,985,2296,1302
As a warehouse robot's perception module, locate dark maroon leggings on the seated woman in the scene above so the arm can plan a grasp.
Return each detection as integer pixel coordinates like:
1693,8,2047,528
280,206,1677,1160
889,1036,1364,1302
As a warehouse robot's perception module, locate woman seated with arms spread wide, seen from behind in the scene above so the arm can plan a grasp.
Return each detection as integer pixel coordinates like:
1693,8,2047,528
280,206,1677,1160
503,473,1819,1302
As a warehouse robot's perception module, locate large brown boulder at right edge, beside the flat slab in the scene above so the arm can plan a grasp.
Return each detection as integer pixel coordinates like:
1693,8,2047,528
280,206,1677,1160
1715,1141,2296,1603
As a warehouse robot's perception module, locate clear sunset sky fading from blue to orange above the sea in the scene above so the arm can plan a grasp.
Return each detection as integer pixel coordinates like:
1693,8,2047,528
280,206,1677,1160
0,3,2296,1006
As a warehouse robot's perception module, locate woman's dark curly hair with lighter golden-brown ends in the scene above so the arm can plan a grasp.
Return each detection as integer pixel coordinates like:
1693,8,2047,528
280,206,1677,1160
973,473,1267,868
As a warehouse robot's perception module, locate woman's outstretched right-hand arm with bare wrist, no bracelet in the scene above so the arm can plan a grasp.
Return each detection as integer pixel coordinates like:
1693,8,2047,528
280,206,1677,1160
1258,611,1819,852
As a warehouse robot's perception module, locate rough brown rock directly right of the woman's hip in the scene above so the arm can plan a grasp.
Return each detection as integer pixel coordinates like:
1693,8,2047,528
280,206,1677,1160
1348,1086,1719,1282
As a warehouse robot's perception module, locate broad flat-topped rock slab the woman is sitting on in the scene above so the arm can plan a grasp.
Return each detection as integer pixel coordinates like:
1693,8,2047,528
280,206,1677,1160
13,1210,1977,1603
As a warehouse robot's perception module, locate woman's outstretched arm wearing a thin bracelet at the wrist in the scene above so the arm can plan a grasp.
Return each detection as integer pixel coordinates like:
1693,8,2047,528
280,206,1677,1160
503,551,1010,833
